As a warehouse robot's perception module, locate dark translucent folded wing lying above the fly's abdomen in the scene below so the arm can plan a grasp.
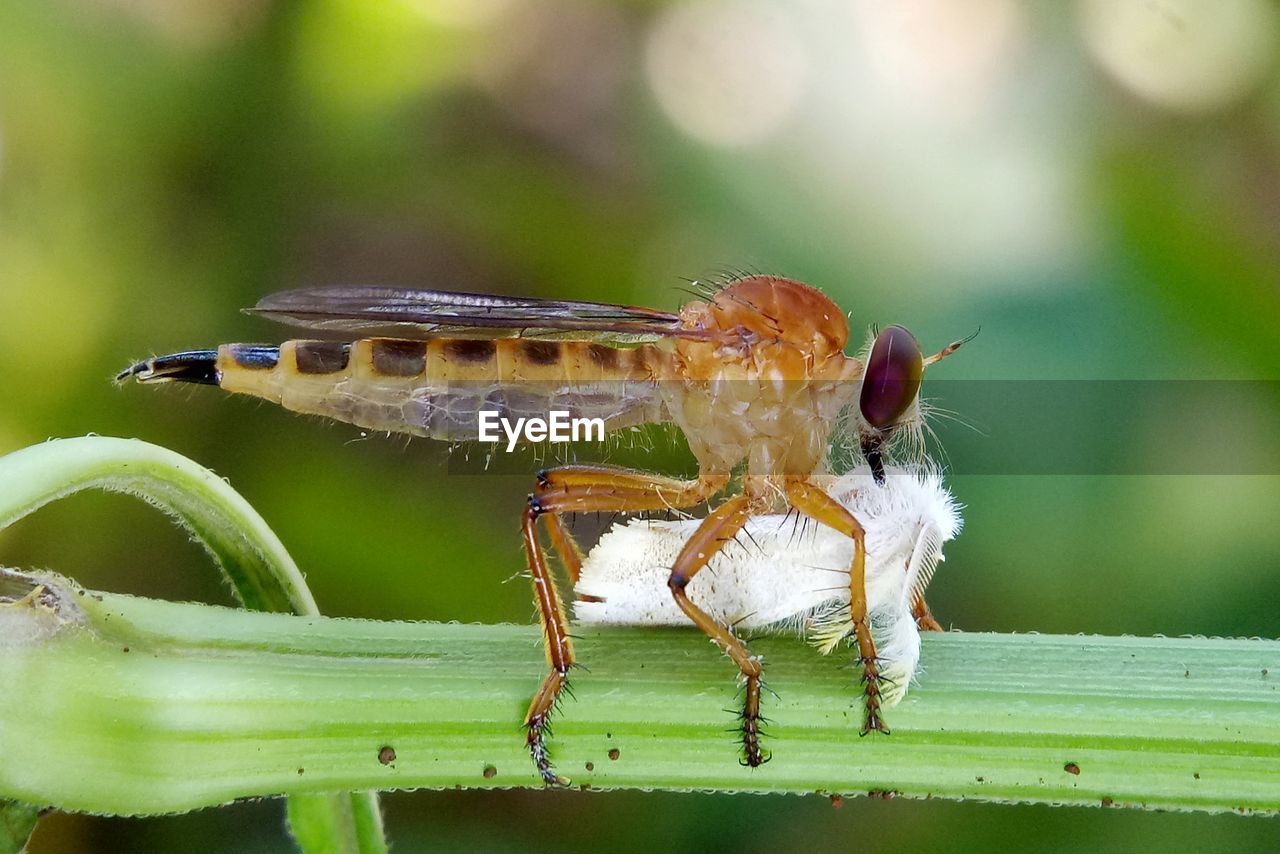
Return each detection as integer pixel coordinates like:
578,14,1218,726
246,286,705,344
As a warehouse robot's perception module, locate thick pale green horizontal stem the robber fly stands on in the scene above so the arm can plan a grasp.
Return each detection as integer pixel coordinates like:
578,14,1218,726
0,576,1280,814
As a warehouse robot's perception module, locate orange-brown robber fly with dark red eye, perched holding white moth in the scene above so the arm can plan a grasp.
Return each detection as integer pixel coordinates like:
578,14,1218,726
119,275,964,784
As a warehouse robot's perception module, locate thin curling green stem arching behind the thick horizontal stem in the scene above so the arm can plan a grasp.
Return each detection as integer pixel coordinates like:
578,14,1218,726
0,437,387,854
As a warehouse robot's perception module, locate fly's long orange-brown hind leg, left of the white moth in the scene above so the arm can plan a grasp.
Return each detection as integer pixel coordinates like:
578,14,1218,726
521,466,728,785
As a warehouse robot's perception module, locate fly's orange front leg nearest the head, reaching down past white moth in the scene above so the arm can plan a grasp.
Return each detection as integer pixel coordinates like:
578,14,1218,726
786,478,888,735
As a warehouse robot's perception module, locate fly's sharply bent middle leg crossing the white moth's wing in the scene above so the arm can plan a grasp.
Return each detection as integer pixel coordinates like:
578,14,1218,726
667,495,768,768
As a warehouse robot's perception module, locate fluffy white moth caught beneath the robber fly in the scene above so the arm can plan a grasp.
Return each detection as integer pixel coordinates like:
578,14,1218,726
573,466,961,705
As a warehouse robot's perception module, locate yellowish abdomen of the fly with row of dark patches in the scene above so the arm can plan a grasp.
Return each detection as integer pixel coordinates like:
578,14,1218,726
216,338,667,440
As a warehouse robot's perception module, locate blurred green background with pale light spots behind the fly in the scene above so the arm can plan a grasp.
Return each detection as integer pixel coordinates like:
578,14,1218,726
0,0,1280,851
